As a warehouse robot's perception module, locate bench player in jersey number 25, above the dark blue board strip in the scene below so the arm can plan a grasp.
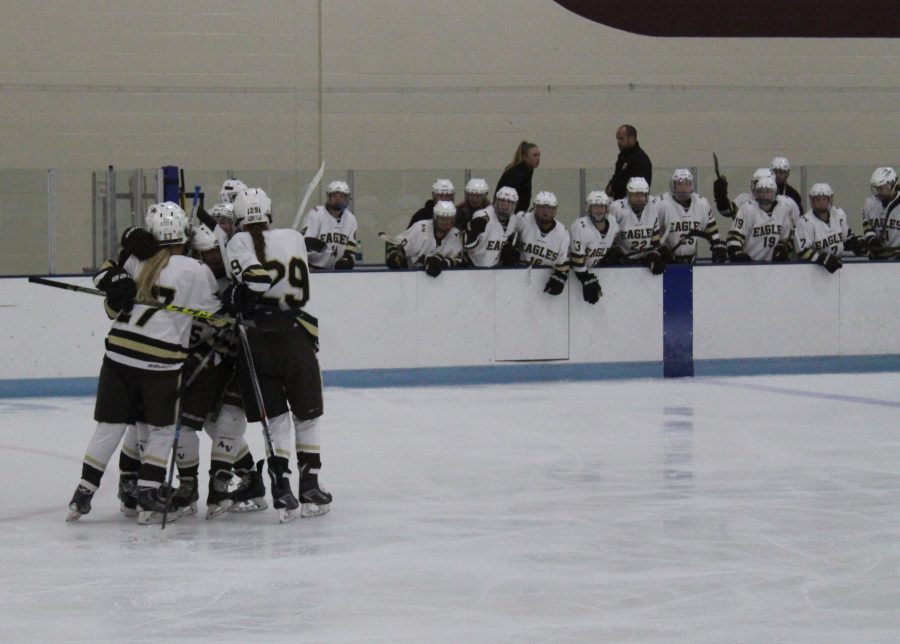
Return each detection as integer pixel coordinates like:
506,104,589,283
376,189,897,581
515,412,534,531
660,168,728,264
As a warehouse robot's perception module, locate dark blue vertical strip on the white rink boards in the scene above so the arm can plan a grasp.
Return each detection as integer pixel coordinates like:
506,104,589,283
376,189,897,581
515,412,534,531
663,264,694,378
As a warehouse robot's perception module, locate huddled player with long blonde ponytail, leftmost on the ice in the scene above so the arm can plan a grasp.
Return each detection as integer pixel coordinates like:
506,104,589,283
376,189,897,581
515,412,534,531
68,202,220,523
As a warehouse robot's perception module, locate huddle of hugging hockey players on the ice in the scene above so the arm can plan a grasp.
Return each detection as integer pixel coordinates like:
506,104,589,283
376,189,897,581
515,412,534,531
68,179,332,524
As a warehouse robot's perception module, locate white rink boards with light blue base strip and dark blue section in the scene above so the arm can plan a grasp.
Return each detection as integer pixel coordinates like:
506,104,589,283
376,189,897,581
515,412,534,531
0,262,900,396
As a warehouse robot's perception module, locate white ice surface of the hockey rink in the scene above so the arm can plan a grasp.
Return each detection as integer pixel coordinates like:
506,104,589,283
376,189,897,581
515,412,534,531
0,374,900,643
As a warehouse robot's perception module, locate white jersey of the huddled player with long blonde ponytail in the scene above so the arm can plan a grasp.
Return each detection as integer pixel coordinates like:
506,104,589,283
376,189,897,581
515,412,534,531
100,255,222,371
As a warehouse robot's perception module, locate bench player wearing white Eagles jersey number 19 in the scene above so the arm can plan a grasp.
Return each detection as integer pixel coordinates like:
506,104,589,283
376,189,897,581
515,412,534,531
727,177,793,262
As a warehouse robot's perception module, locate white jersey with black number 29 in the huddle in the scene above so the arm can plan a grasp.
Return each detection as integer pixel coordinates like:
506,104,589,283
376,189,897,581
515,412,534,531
228,228,319,336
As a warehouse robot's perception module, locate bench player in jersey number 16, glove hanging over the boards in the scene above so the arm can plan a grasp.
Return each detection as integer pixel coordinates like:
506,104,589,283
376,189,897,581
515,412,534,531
509,190,569,295
